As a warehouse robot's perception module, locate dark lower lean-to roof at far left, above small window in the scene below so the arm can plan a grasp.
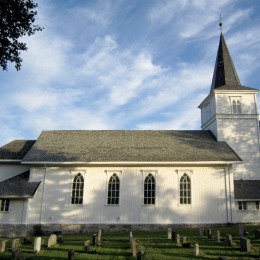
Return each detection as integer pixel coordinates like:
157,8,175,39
0,171,41,198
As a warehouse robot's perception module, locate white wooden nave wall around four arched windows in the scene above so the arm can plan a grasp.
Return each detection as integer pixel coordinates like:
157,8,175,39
27,167,235,224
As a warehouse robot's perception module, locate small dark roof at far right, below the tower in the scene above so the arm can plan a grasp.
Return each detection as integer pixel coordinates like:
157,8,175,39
234,180,260,200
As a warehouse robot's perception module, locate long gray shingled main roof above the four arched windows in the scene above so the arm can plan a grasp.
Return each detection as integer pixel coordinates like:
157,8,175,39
23,130,241,162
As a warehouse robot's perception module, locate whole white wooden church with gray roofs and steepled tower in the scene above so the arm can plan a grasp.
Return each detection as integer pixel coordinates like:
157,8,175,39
0,33,260,236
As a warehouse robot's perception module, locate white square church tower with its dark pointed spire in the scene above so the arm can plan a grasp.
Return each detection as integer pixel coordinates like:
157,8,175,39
199,32,260,180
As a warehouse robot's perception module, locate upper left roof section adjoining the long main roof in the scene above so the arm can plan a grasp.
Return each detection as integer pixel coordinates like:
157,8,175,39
0,140,35,160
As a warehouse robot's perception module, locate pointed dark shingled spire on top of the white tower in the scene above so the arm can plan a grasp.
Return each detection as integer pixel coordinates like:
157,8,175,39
210,32,241,92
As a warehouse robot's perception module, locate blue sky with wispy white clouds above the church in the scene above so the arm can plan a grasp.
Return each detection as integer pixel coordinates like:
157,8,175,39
0,0,260,146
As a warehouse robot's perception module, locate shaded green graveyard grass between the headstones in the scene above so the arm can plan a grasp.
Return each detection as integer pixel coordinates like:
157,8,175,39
0,226,260,260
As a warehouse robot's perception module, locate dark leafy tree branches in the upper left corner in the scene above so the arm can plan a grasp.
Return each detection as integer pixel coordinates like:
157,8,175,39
0,0,43,70
